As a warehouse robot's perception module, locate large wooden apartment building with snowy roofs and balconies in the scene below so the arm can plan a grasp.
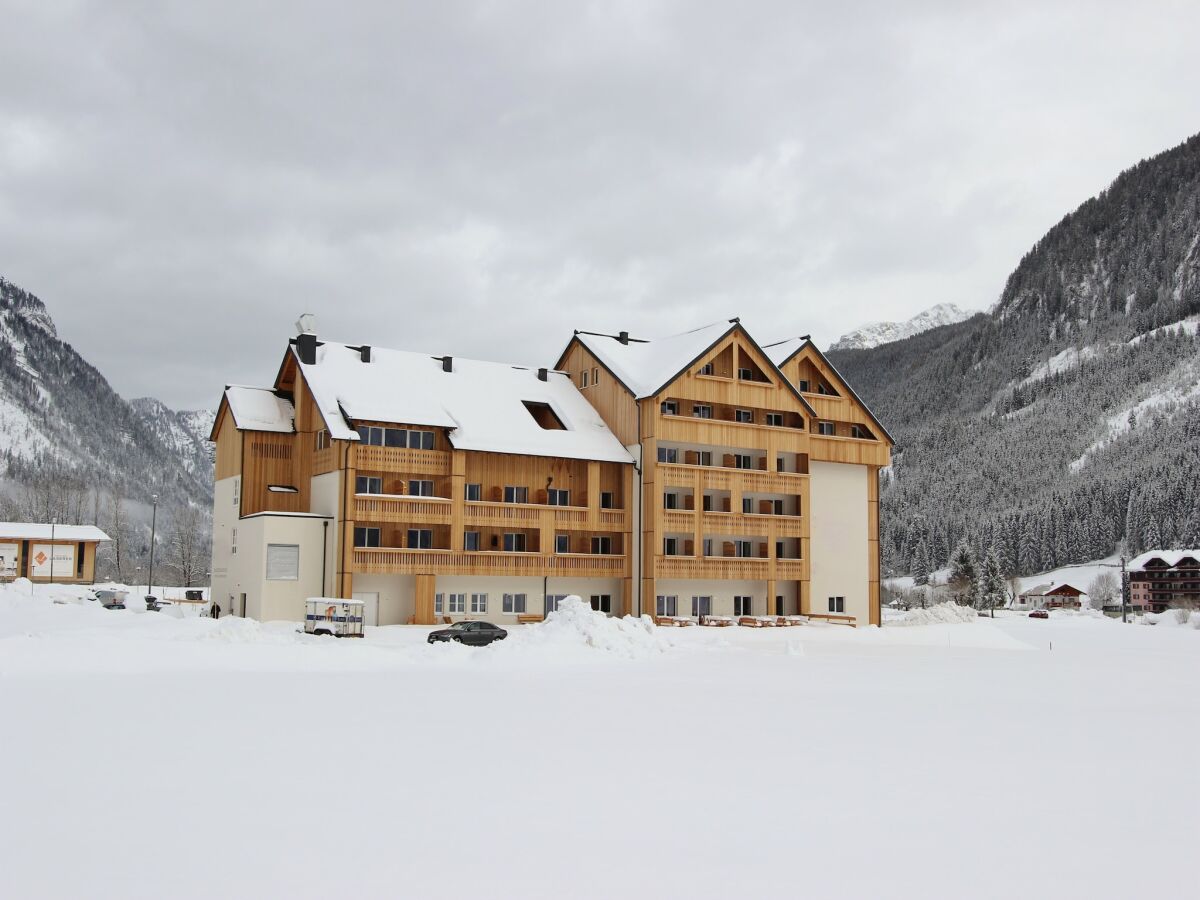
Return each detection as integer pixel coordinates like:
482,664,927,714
211,320,892,624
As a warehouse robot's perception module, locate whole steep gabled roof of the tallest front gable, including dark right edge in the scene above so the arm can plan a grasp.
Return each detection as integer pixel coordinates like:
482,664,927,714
558,319,816,415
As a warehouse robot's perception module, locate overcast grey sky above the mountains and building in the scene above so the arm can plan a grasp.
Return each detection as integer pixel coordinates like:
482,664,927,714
0,0,1200,407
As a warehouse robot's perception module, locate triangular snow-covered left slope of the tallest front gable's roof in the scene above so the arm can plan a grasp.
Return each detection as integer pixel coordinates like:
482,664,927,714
575,320,736,400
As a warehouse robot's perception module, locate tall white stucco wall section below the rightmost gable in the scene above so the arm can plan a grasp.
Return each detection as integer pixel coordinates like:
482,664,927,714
809,462,871,625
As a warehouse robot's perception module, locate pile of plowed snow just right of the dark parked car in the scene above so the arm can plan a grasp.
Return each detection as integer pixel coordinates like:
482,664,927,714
494,595,672,659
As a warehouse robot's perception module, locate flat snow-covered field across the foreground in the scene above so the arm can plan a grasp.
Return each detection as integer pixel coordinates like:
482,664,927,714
0,580,1200,898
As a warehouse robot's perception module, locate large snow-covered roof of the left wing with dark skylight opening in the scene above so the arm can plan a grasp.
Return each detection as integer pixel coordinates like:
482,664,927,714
293,341,632,462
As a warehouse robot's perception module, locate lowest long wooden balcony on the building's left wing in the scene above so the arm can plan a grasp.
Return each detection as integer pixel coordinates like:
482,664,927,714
354,547,628,578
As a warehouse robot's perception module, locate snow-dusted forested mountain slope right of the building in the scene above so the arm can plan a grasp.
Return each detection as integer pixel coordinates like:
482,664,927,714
830,136,1200,574
